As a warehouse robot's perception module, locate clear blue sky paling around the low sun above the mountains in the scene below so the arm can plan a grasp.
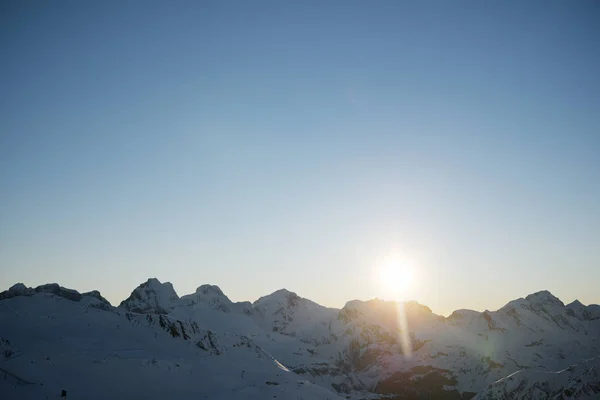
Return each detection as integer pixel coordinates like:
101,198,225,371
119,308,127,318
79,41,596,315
0,0,600,315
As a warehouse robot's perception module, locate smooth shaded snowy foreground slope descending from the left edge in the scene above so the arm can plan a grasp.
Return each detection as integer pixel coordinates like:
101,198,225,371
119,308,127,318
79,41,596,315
0,284,337,400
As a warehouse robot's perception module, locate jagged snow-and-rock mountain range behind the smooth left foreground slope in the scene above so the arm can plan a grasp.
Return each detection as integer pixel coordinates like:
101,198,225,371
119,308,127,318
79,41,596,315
0,279,600,399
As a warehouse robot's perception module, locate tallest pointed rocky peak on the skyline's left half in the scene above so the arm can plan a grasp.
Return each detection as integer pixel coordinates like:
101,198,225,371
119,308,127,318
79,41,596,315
120,278,179,314
